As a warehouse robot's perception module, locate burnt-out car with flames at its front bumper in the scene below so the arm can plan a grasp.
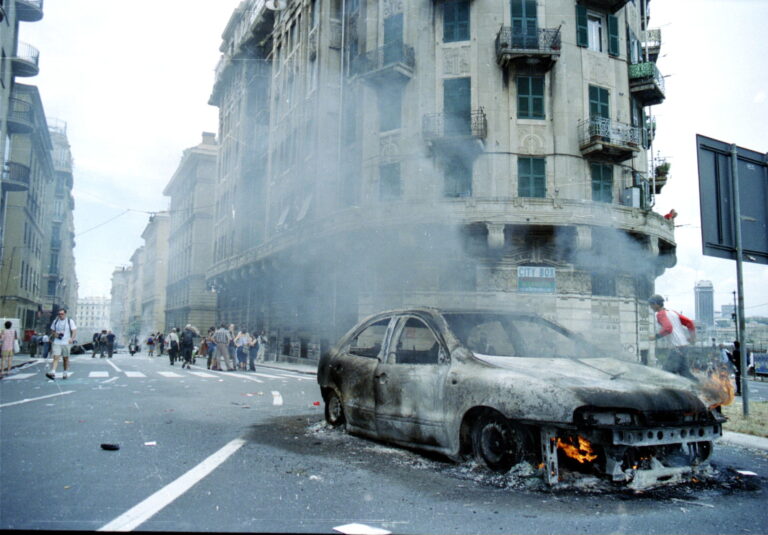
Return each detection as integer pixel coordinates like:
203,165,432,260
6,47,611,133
317,308,724,486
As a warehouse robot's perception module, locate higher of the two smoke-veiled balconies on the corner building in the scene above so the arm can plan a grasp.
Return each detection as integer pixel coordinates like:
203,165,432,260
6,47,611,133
351,42,416,85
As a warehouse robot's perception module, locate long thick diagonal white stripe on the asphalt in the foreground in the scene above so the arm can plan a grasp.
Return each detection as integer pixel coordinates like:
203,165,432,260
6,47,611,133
98,438,245,531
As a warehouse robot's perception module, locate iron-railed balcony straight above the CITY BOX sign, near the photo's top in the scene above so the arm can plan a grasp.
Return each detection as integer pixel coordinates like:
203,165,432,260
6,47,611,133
496,26,560,70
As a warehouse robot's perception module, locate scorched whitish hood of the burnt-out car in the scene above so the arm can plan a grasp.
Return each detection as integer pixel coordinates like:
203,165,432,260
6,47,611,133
475,354,707,413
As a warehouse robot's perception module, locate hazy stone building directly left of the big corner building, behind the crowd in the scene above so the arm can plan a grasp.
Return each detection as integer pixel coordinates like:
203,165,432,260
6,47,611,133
163,132,218,331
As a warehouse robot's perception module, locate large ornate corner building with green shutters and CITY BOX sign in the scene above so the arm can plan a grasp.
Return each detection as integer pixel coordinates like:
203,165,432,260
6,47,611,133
207,0,676,359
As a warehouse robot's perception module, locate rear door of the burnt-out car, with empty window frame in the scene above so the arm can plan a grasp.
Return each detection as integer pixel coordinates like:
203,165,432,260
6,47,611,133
330,317,395,432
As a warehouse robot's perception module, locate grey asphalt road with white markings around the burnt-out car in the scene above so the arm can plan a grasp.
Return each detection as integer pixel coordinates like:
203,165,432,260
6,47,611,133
0,354,768,533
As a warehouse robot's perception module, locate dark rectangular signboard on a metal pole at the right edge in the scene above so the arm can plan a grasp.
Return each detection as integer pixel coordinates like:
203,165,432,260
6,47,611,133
696,135,768,264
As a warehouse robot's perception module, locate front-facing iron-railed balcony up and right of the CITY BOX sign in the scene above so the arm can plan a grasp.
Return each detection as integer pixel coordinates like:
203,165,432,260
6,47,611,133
579,117,642,163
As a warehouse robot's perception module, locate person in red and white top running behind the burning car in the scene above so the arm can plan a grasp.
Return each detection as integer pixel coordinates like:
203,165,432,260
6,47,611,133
648,294,696,381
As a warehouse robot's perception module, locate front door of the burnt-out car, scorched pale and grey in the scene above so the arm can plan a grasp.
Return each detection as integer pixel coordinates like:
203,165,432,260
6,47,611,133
374,315,449,446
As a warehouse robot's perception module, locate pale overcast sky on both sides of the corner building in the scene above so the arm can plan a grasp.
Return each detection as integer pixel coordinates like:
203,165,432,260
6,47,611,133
20,0,768,316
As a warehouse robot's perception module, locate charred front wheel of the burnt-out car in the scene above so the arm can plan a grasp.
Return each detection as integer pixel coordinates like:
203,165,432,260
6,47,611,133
472,413,522,472
